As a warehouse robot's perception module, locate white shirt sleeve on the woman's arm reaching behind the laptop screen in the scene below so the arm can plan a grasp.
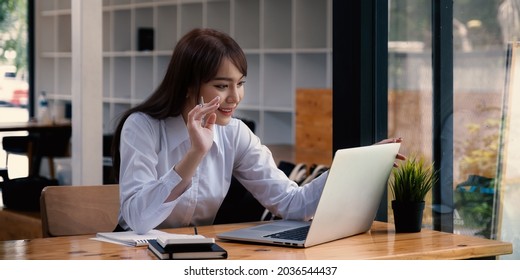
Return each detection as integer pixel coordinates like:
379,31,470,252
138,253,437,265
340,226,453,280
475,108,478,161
233,120,328,220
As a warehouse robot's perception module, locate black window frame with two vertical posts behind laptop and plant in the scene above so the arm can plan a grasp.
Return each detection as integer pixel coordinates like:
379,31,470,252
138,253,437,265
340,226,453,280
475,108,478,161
332,0,453,232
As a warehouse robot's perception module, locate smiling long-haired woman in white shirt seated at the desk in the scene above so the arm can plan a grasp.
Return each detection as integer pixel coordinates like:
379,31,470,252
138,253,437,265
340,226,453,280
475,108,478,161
113,29,400,233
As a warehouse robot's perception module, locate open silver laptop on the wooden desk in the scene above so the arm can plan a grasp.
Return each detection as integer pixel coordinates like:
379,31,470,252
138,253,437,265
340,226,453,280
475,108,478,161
217,143,400,247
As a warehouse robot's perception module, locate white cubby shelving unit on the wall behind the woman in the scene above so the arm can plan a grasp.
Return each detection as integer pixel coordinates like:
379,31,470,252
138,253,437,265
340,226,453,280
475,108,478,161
35,0,332,144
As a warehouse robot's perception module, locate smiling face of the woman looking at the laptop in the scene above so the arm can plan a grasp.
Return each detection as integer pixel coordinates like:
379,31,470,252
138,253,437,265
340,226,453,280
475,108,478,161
200,59,245,125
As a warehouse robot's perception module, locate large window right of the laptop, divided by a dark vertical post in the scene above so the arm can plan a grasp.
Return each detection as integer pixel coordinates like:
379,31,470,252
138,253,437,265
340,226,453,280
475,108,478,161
388,0,520,259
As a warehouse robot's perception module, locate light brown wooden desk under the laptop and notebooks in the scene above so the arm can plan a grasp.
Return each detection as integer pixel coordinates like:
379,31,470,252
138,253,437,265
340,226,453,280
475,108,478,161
0,222,513,260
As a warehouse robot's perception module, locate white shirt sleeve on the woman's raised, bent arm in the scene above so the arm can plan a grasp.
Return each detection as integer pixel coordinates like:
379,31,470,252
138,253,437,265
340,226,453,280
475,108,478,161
119,114,182,234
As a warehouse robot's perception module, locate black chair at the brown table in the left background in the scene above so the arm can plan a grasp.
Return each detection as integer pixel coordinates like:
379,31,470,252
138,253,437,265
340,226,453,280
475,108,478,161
2,127,72,179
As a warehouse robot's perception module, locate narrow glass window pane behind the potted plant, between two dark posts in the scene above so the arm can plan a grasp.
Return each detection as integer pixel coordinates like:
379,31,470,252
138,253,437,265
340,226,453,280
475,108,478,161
388,0,433,228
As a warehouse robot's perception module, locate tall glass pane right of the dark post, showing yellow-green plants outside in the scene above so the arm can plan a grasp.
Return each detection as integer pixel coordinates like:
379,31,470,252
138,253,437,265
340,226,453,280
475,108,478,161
453,1,505,238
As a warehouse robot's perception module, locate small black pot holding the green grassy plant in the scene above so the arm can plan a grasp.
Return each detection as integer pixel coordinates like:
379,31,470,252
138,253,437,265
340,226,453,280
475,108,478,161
392,200,424,233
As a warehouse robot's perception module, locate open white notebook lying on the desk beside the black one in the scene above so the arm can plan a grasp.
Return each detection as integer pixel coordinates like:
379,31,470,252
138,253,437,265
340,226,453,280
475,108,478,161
94,229,215,246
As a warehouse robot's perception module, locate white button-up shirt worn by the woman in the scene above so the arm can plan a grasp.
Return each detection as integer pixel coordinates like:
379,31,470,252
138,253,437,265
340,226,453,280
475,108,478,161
119,113,328,233
